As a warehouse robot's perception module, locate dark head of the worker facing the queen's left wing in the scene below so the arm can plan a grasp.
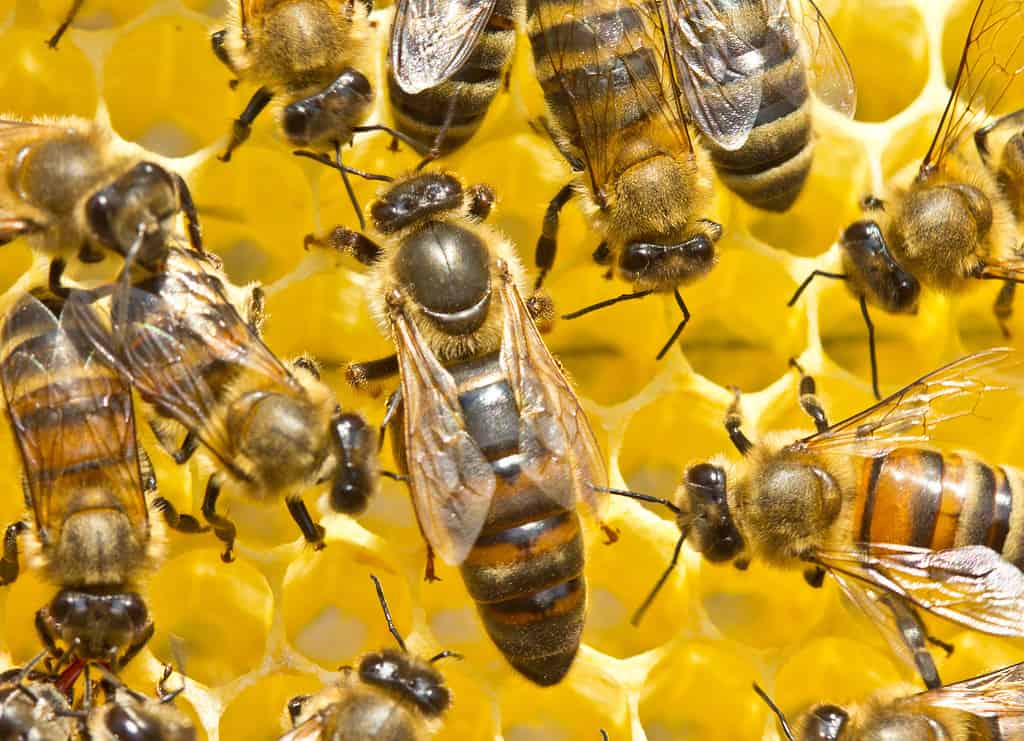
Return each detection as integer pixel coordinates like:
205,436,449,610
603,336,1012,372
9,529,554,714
330,415,377,515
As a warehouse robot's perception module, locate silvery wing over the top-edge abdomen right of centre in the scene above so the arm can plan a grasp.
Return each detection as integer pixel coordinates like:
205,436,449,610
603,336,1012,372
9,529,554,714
665,0,765,150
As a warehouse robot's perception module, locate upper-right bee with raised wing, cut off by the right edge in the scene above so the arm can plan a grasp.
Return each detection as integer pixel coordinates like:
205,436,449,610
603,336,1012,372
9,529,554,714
790,0,1024,398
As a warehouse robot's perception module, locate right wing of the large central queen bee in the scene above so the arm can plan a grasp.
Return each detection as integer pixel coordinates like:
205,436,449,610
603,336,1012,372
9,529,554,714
500,269,607,516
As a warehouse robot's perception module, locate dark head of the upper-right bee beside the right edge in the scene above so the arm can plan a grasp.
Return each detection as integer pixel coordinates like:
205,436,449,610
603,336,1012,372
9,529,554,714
839,220,921,314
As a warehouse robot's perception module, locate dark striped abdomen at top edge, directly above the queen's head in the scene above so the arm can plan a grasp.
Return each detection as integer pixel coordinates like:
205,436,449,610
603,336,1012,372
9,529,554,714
388,0,515,154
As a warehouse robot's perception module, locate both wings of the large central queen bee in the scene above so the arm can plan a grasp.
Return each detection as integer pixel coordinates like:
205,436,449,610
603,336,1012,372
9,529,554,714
391,269,607,565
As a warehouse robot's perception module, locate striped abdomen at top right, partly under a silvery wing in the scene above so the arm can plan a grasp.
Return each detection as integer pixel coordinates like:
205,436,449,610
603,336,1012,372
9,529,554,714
703,3,814,211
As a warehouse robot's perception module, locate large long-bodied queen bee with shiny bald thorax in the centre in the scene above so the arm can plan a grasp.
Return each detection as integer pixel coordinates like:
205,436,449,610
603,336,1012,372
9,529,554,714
311,173,610,686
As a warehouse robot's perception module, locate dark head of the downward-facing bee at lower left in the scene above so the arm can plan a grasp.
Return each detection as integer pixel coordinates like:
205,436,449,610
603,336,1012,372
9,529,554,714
36,589,153,667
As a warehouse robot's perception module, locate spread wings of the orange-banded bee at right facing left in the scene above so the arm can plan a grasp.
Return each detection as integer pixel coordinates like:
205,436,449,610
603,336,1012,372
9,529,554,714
788,348,1024,664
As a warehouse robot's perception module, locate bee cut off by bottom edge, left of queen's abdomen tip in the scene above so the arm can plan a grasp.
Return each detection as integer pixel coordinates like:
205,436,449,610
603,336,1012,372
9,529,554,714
280,576,458,741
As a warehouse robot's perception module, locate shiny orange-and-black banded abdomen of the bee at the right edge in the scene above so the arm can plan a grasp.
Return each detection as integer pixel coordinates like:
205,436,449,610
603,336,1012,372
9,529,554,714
853,448,1024,568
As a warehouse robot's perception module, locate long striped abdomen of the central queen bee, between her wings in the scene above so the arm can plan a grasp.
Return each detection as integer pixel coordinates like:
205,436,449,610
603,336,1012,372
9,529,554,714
450,353,587,686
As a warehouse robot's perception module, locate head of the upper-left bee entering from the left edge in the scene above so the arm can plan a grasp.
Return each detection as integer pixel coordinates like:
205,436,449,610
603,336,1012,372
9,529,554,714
85,162,181,265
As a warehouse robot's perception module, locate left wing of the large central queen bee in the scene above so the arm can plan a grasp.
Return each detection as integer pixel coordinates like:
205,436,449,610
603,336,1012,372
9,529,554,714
392,298,496,565
